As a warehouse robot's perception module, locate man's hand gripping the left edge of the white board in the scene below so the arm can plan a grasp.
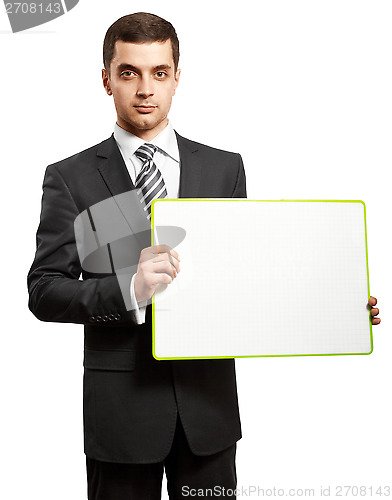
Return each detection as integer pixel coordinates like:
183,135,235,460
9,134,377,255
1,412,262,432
134,245,180,302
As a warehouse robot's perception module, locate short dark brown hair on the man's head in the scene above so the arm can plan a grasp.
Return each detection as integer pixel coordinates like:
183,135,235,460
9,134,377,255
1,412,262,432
103,12,180,73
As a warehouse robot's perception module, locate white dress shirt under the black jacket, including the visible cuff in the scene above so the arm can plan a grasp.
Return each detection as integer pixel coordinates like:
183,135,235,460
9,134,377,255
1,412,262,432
114,123,180,324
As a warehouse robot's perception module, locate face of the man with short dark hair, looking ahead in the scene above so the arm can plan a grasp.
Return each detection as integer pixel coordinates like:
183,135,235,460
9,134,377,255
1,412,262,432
102,40,180,141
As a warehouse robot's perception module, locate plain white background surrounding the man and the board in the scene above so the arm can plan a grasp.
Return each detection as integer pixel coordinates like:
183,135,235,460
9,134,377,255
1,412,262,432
0,0,392,500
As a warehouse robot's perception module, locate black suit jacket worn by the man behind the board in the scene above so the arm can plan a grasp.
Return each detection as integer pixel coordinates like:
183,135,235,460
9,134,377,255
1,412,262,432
28,134,246,463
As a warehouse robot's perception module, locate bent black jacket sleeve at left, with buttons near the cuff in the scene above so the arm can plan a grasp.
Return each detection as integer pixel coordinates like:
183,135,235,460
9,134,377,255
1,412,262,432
27,165,137,326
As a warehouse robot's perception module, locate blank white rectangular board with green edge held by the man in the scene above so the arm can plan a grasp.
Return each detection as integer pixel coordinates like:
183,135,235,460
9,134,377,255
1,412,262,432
152,199,372,359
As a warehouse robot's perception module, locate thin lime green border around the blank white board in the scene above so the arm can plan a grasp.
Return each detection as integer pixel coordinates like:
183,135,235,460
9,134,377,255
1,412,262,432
151,198,373,361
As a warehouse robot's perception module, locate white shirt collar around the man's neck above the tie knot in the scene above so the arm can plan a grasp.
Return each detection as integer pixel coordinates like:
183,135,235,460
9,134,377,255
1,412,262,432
114,122,180,162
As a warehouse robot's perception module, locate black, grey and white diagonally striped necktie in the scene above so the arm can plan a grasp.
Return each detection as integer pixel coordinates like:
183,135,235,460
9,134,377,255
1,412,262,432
135,143,167,220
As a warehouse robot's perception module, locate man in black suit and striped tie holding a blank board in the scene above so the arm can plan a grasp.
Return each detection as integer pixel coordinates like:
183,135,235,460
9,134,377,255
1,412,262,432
28,13,378,500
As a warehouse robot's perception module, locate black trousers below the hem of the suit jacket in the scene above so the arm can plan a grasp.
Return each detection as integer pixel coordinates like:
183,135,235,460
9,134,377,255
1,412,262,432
86,418,237,500
